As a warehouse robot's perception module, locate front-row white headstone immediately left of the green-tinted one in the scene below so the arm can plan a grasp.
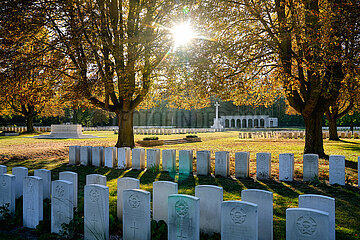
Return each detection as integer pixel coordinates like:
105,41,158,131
123,189,151,240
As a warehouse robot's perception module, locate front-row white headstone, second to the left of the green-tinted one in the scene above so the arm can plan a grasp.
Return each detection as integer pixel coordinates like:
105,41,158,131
84,184,109,240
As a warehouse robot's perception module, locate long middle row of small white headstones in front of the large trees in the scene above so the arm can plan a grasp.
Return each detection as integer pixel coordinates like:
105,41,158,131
69,146,360,185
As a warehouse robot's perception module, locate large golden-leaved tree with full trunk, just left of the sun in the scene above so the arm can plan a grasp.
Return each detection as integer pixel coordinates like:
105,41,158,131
48,0,183,147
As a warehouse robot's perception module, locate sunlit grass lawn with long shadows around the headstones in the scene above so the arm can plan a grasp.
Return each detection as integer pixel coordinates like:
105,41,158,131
0,132,360,239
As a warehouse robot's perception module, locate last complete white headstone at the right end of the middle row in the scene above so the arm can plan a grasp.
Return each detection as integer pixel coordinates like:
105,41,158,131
329,155,345,186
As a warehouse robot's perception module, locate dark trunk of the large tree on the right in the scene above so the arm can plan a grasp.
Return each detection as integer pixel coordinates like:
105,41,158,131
303,110,327,158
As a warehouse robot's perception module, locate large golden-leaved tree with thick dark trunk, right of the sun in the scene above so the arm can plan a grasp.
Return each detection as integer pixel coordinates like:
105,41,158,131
188,0,359,157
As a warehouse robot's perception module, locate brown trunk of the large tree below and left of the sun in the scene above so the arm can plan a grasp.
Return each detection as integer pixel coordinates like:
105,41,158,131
115,110,135,148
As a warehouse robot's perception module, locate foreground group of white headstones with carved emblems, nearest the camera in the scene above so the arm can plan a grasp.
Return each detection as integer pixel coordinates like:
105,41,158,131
0,168,335,240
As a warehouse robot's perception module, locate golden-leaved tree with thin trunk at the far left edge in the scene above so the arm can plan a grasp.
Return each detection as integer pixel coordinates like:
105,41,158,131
0,0,63,132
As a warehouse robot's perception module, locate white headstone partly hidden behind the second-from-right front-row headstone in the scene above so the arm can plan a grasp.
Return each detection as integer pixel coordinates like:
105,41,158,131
241,189,273,240
